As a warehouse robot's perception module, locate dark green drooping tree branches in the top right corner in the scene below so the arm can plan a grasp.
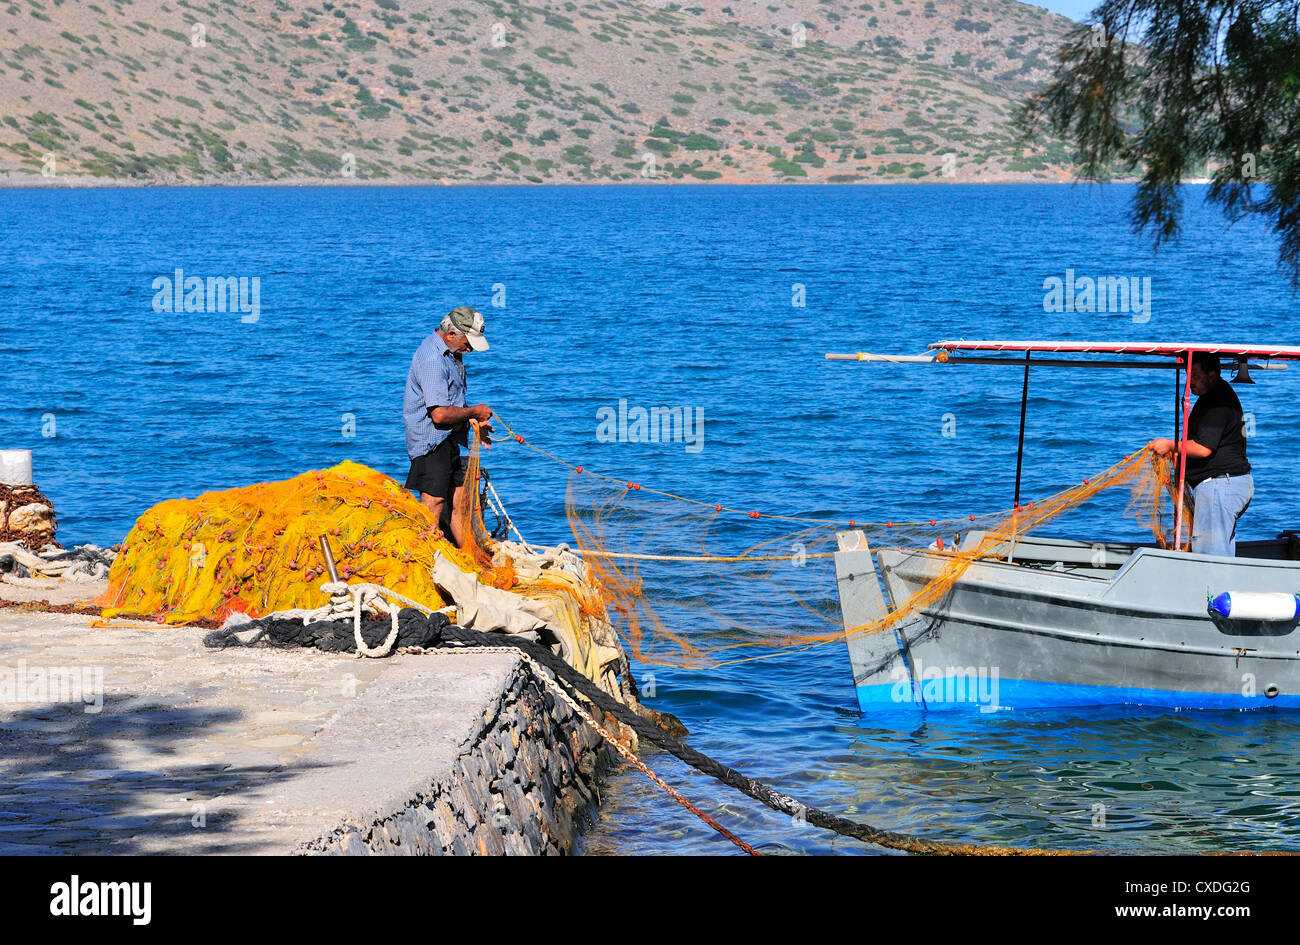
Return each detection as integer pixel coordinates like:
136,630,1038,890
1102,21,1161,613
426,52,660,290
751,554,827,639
1024,0,1300,289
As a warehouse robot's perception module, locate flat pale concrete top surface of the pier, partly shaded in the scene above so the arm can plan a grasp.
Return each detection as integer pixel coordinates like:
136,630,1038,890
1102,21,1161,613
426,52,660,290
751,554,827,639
0,584,517,854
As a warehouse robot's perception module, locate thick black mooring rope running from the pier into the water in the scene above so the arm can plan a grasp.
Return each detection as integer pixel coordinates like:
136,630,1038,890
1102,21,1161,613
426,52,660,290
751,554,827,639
203,607,1075,857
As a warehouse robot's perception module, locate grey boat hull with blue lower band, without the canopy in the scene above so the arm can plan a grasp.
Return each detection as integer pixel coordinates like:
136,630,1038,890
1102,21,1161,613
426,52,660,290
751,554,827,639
837,539,1300,712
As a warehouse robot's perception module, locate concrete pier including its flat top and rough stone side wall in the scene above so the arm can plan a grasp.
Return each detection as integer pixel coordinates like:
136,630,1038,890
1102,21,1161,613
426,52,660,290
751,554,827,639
0,597,608,854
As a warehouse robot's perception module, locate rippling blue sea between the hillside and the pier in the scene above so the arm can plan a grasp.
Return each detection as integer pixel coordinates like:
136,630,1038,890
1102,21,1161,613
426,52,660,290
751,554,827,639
0,186,1300,854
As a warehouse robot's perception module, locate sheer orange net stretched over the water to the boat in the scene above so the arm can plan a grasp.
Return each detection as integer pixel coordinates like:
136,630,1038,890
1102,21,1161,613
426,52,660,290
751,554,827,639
564,447,1191,667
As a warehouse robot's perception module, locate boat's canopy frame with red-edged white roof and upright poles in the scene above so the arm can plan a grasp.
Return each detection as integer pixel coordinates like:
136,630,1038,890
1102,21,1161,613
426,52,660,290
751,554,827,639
826,339,1300,549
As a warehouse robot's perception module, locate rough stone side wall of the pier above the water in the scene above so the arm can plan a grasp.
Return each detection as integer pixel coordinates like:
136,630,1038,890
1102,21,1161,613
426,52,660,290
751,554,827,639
300,662,614,855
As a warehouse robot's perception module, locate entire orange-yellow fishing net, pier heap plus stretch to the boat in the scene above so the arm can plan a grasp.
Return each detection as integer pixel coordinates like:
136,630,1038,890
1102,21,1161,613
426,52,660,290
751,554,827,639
95,413,1191,681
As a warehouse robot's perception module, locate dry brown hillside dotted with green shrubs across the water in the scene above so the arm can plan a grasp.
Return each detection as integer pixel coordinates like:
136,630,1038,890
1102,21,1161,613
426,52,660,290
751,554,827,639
0,0,1073,183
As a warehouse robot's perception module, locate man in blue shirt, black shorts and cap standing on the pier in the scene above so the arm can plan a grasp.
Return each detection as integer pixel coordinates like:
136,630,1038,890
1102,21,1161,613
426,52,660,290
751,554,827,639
402,305,491,546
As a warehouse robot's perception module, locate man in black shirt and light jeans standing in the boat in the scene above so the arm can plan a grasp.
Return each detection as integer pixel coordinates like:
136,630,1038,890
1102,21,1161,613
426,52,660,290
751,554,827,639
1149,351,1255,558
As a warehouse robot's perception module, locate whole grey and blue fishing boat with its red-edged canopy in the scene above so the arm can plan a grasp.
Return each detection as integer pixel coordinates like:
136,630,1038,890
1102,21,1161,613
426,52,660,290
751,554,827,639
827,341,1300,712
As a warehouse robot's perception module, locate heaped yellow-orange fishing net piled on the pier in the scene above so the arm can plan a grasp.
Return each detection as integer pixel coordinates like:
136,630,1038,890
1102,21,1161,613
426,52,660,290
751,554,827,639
94,438,603,631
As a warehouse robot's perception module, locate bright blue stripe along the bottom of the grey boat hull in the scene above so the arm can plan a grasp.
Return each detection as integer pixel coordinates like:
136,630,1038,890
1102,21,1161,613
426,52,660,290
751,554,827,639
858,676,1300,712
